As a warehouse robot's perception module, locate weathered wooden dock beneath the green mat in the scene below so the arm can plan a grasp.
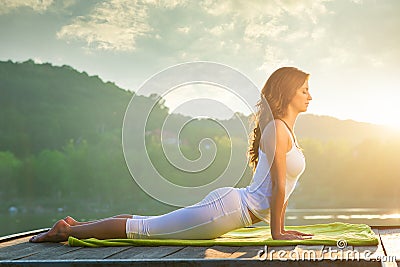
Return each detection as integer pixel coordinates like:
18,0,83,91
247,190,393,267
0,226,400,267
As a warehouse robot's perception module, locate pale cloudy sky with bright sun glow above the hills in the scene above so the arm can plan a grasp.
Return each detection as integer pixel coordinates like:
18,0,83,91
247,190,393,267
0,0,400,128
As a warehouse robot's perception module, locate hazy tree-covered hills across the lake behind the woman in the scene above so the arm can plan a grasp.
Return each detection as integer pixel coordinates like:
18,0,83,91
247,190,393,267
0,60,400,219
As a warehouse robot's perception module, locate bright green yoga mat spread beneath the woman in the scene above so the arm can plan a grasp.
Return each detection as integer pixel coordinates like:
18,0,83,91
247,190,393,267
68,222,378,247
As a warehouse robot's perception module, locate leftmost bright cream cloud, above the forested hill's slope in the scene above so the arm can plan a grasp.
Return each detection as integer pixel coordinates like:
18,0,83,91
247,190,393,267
57,0,186,51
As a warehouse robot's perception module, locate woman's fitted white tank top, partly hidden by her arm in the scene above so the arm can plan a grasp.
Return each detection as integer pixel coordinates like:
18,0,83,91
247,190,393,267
239,123,306,224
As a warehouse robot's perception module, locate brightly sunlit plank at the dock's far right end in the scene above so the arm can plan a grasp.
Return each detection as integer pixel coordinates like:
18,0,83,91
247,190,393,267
379,228,400,262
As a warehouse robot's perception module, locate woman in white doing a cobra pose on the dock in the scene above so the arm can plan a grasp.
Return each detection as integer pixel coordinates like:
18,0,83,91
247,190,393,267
30,67,312,242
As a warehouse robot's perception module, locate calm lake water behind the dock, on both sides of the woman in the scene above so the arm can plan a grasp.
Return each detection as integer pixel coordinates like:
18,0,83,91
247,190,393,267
0,209,400,236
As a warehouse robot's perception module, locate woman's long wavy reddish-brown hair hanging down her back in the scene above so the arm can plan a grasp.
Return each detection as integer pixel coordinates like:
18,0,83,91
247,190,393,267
247,67,309,172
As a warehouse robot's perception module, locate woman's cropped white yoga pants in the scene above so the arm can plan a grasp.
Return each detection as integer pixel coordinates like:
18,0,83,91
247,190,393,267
126,187,252,239
